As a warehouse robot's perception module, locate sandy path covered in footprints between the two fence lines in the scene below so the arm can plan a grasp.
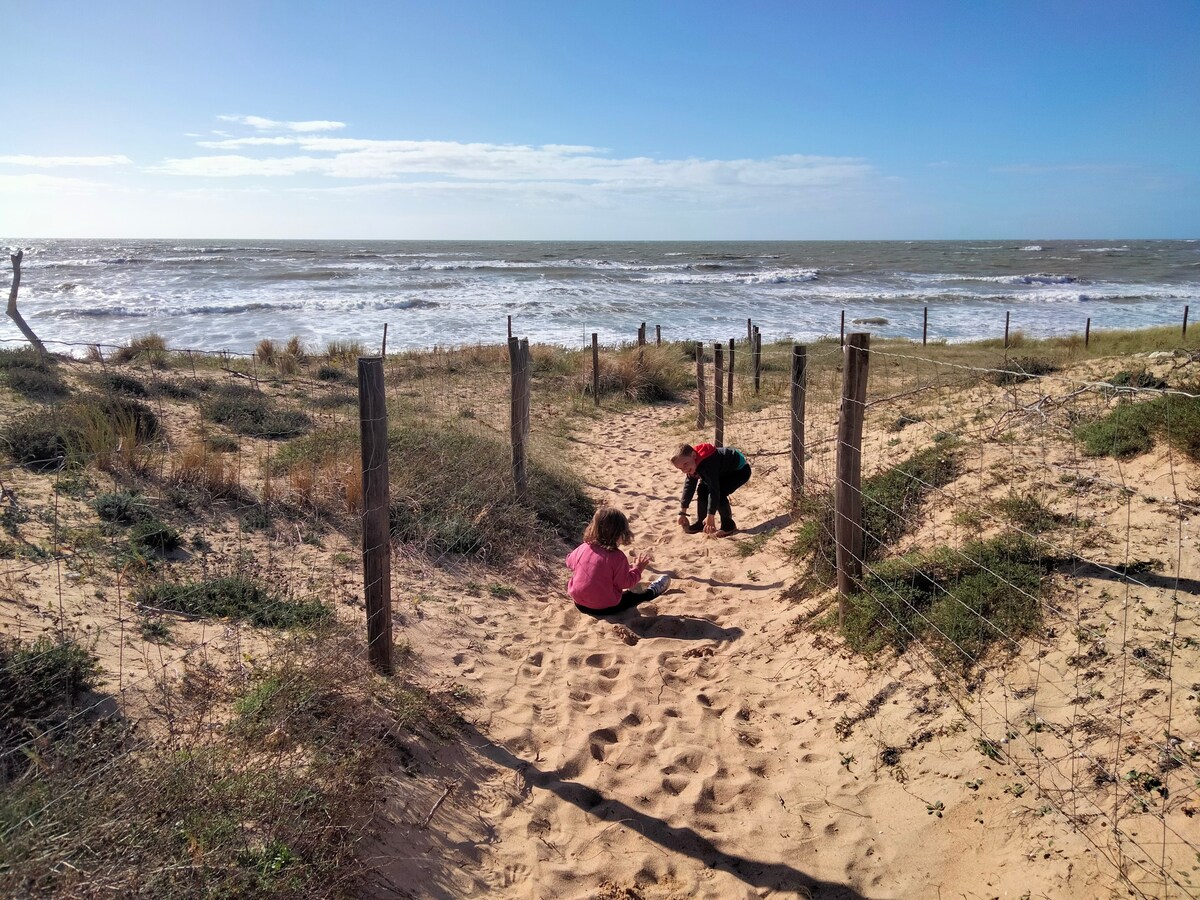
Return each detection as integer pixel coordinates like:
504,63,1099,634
372,408,1115,900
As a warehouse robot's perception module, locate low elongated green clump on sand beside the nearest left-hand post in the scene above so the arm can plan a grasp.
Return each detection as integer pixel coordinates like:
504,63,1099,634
134,575,334,628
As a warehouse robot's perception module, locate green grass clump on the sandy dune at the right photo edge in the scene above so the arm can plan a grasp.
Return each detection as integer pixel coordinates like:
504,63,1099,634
1075,384,1200,460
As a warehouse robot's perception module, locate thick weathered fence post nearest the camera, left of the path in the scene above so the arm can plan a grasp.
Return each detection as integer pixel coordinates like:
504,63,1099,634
359,356,395,674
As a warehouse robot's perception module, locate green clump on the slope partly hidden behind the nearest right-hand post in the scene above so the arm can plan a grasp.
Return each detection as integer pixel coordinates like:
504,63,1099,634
790,440,961,582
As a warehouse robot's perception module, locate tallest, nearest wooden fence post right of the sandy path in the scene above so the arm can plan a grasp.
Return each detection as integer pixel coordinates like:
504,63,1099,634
834,331,871,628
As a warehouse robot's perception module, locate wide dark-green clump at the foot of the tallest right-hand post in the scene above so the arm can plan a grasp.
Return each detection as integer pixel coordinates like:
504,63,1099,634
842,534,1054,670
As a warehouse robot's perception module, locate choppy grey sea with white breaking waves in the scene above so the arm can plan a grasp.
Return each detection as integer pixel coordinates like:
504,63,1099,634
0,239,1200,355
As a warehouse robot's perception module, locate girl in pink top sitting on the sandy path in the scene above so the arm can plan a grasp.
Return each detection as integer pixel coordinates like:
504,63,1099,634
566,506,671,616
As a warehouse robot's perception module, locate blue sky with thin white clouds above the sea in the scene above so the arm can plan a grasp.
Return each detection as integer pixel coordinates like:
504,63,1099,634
0,0,1200,240
